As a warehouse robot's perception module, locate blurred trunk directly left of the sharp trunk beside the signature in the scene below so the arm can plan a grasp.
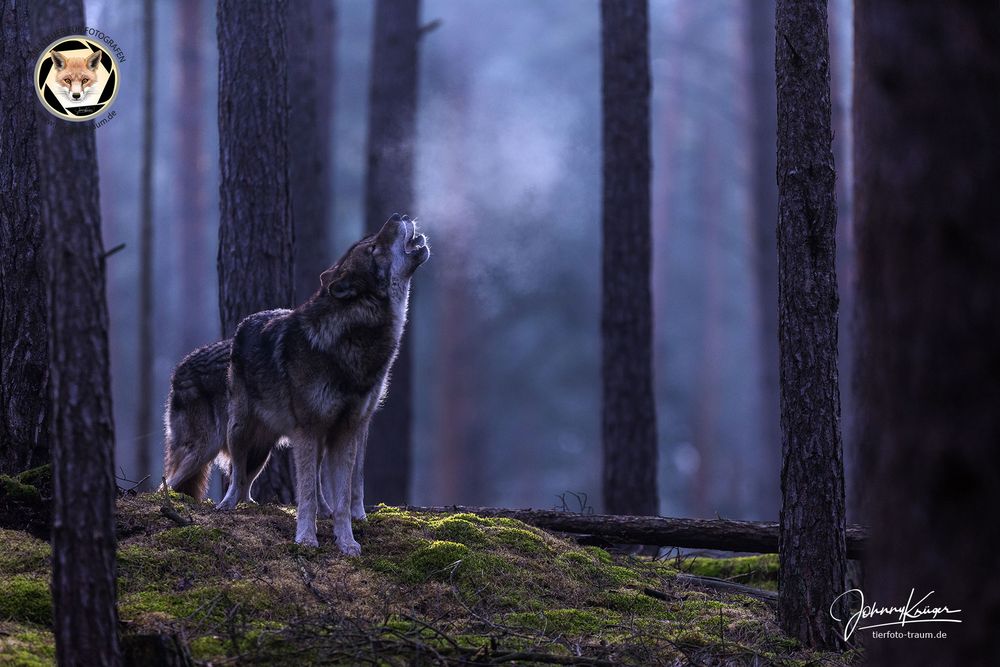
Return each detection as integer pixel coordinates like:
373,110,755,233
746,0,781,517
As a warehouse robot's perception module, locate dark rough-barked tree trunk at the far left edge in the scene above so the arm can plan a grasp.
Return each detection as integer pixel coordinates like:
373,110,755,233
0,0,49,473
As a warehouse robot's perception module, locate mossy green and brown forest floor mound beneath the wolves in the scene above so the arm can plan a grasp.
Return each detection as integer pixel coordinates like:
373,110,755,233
0,470,857,665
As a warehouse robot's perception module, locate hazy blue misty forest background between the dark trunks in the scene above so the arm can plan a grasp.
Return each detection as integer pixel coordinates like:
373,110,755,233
86,0,853,520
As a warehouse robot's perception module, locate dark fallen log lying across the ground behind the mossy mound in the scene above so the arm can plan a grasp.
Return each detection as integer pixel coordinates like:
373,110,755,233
392,505,868,559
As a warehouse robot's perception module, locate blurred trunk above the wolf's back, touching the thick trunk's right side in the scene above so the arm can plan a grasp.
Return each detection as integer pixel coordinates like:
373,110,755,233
288,0,336,303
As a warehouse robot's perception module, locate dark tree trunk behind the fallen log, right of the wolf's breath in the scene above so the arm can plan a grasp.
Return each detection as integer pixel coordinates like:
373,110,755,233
601,0,659,514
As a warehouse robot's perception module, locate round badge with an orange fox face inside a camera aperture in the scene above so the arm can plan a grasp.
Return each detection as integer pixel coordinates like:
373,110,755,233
35,35,119,121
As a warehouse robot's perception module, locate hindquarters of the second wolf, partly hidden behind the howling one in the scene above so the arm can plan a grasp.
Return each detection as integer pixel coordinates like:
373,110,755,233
163,339,232,500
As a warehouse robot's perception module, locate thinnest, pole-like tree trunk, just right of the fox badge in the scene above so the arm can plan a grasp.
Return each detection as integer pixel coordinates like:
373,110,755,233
135,0,159,488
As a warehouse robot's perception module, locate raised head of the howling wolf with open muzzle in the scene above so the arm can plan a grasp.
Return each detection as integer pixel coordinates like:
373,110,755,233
320,213,431,301
